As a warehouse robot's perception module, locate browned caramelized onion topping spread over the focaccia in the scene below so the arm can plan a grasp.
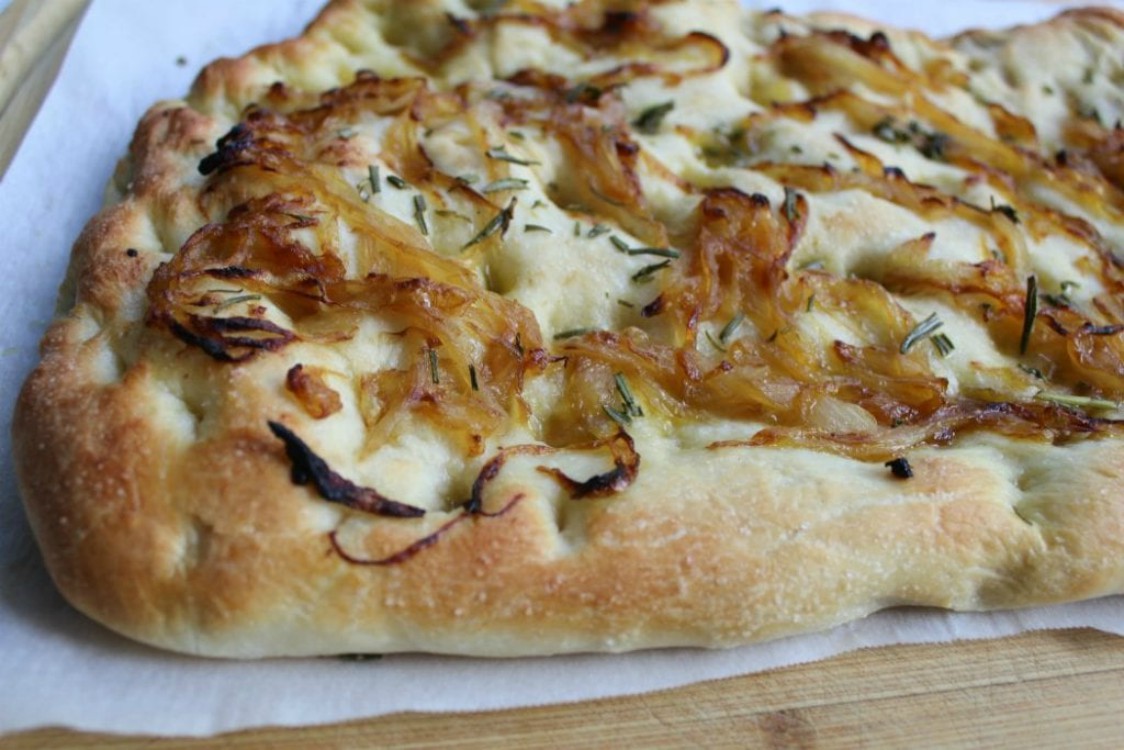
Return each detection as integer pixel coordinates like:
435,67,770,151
148,2,1124,503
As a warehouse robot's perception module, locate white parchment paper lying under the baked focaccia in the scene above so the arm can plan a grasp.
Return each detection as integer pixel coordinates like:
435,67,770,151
0,0,1124,735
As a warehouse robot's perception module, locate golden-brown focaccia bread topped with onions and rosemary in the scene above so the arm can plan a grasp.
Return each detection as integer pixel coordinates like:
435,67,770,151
13,0,1124,657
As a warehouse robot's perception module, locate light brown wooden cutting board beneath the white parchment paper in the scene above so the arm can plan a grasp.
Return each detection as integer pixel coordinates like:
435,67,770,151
0,0,1124,750
